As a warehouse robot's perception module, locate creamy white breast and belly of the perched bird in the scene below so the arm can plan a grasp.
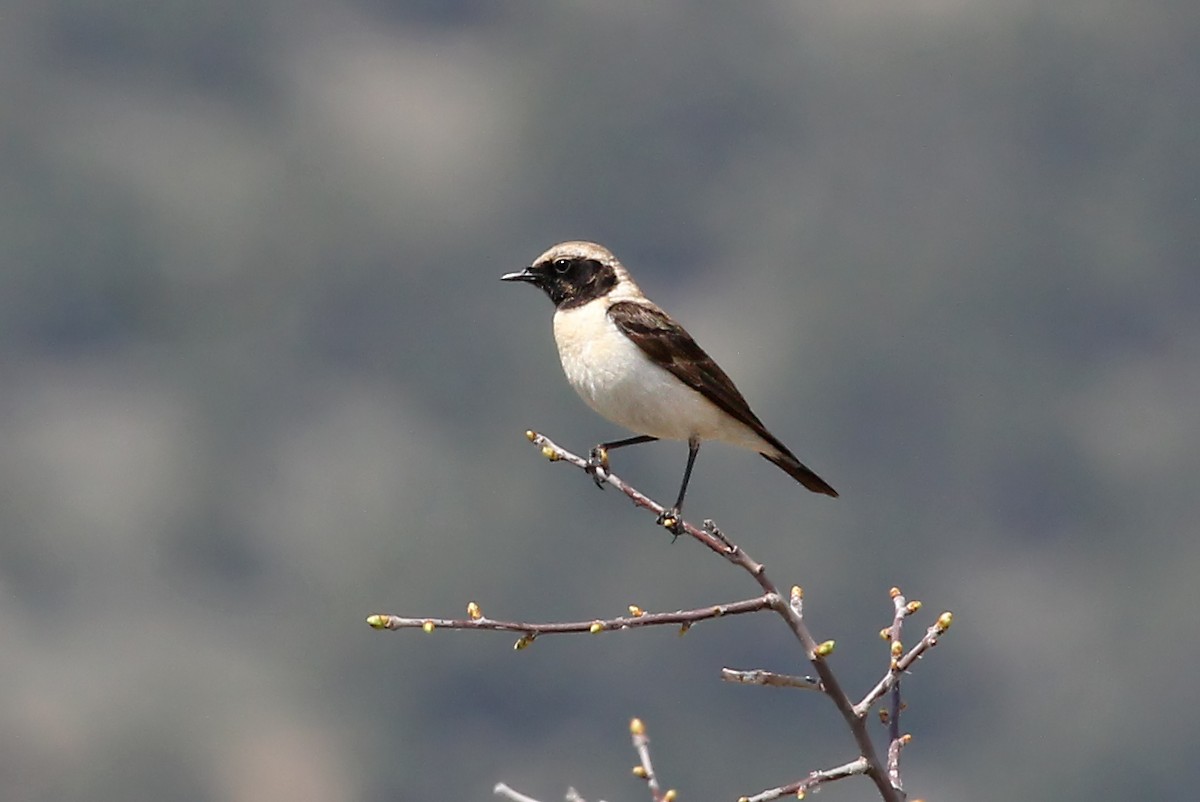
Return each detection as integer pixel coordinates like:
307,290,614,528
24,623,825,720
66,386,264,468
554,299,773,451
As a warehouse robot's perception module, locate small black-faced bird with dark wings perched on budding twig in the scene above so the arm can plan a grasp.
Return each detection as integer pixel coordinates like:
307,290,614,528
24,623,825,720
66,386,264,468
500,240,838,535
